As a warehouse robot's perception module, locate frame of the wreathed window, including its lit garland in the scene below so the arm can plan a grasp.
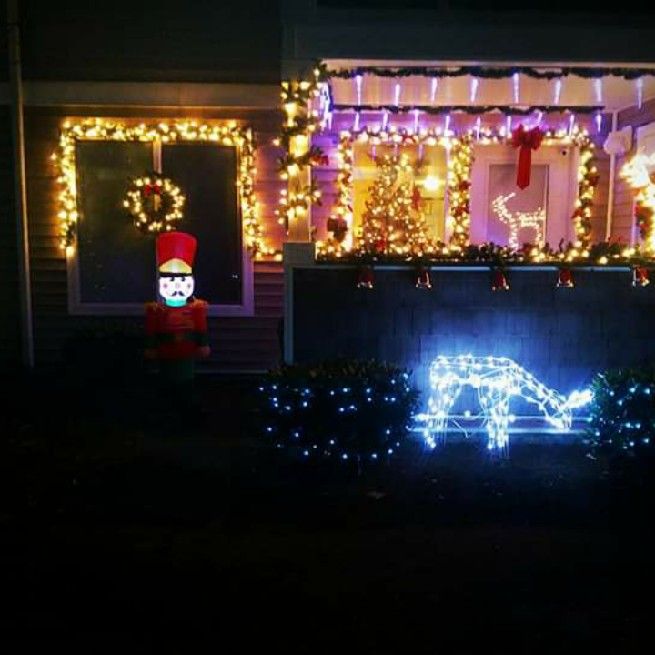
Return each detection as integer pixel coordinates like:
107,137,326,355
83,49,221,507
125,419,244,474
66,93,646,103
58,119,262,317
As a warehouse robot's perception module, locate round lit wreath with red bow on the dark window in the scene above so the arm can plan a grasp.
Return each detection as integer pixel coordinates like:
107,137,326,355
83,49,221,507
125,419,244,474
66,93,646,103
123,173,186,234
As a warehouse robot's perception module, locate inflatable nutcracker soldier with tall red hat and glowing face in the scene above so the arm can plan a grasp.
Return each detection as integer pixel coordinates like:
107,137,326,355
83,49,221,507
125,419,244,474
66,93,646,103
146,232,209,388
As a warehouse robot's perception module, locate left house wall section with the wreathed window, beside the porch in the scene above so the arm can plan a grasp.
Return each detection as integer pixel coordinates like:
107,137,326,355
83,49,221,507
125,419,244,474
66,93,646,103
0,1,283,371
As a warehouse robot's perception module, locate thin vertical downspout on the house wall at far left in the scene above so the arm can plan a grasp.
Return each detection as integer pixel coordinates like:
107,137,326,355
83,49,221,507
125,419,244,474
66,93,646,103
7,0,34,369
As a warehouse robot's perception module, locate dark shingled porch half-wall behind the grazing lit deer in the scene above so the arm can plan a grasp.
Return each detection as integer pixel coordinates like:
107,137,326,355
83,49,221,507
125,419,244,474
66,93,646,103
293,267,655,393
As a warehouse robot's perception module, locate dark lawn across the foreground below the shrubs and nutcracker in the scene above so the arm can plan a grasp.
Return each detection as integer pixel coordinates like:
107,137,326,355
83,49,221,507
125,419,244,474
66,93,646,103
0,378,653,653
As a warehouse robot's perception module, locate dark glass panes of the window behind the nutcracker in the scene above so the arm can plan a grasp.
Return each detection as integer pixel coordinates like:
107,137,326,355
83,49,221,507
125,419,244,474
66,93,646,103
76,141,243,305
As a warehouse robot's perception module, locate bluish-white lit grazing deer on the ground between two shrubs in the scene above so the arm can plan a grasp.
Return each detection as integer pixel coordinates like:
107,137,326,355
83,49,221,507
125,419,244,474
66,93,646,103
424,355,591,451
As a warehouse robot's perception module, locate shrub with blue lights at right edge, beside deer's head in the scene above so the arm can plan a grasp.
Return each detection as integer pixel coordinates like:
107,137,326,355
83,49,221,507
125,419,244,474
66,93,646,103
590,367,655,454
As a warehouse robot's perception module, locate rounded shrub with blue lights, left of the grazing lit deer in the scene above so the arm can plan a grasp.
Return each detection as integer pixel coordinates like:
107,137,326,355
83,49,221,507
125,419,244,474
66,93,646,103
259,359,418,460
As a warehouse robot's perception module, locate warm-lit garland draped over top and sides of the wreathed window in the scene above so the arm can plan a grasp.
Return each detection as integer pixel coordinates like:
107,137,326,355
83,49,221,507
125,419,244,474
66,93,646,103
53,118,277,258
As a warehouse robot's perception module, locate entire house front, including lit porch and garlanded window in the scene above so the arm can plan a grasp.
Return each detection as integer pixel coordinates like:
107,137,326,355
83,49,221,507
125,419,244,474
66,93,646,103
0,0,655,384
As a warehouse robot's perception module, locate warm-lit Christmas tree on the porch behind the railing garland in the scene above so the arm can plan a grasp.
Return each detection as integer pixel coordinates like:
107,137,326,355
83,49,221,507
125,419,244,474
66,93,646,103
357,155,434,257
